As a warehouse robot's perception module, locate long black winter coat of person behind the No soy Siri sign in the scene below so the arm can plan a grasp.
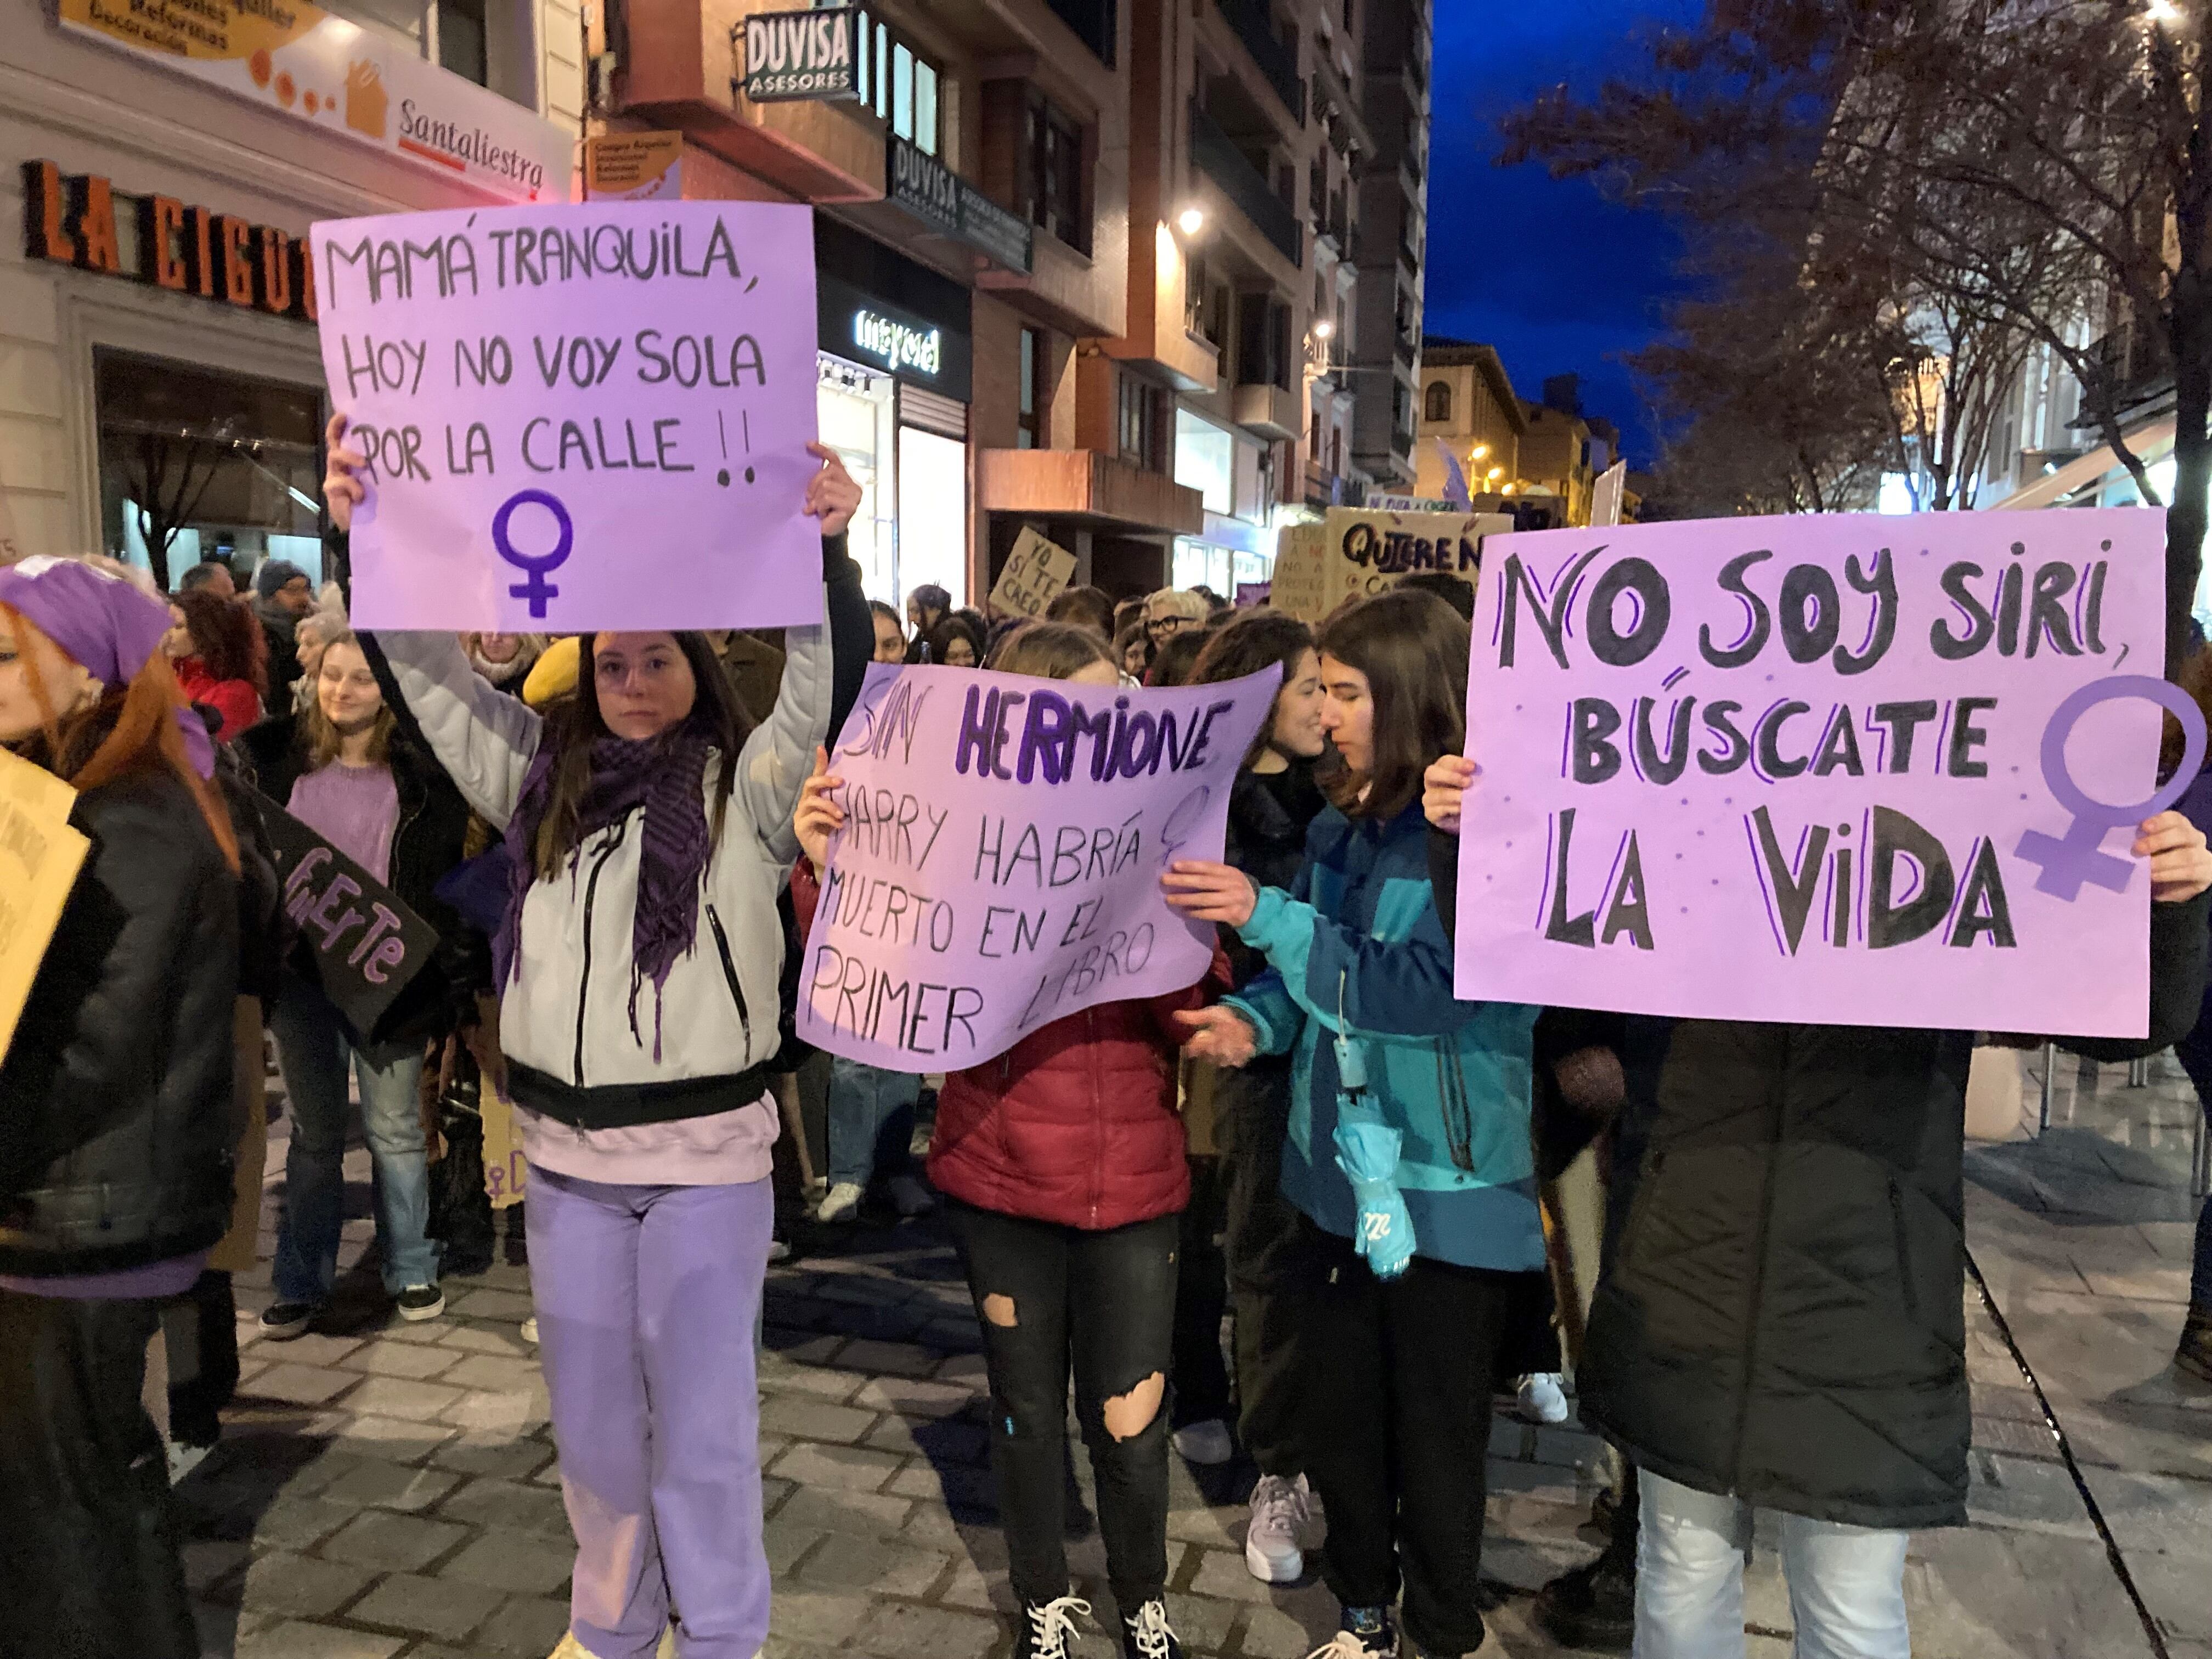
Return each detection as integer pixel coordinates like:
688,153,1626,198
1429,834,2212,1528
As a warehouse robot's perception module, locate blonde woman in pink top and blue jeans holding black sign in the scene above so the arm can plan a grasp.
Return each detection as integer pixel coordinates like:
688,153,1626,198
239,633,469,1340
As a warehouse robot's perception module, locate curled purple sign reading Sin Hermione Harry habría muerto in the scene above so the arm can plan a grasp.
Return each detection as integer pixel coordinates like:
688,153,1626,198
799,664,1281,1070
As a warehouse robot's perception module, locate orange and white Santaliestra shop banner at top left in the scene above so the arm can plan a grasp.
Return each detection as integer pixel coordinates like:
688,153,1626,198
60,0,575,201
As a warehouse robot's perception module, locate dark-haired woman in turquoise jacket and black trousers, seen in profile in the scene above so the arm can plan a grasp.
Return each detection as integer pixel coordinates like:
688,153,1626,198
1164,591,1544,1659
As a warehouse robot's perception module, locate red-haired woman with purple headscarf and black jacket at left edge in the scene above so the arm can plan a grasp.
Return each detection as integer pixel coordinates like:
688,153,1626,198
0,557,239,1659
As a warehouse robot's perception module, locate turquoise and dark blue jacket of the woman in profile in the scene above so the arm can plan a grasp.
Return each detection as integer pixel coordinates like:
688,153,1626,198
1228,803,1544,1272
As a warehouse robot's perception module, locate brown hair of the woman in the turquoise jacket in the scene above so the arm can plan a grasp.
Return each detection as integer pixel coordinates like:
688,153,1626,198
1321,589,1469,819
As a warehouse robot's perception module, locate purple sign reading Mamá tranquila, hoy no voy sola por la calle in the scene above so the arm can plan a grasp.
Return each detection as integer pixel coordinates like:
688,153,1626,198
312,201,823,633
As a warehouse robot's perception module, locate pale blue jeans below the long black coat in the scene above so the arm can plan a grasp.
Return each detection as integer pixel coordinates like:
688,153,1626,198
1635,1469,1914,1659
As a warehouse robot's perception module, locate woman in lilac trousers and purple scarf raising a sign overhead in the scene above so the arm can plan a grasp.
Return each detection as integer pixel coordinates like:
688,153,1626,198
323,416,874,1659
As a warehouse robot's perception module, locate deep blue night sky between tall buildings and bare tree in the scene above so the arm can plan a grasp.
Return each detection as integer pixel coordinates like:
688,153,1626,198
1425,0,1703,467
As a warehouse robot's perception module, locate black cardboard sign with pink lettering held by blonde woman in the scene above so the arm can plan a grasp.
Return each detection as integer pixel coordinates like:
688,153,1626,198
257,797,438,1042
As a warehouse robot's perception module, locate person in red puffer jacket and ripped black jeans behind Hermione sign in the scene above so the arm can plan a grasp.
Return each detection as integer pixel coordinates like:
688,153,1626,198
794,622,1207,1659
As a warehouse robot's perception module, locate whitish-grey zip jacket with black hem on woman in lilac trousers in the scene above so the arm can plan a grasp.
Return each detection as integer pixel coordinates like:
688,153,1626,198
376,566,874,1128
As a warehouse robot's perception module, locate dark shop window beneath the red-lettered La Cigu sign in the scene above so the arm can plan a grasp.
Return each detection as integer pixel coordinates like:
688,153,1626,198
93,349,323,589
